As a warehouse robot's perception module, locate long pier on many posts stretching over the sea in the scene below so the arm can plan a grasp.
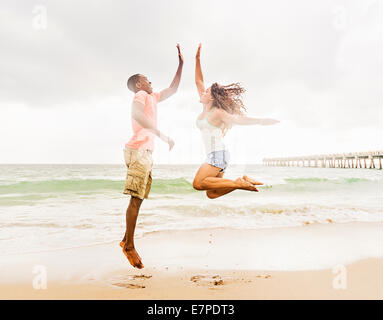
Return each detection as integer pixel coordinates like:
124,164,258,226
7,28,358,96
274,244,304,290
263,150,383,169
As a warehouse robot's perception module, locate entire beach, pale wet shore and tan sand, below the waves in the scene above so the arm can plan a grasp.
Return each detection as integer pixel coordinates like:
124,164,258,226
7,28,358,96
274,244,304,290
0,223,383,299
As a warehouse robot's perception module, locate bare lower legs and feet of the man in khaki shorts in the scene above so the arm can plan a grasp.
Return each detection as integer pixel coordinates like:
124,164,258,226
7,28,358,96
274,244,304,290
123,196,144,269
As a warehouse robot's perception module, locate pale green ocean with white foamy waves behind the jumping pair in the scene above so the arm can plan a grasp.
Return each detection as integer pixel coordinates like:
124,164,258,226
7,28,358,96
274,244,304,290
0,165,383,255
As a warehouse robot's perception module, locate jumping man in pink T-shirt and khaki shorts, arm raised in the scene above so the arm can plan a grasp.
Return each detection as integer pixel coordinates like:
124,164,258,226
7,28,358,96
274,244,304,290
120,44,183,269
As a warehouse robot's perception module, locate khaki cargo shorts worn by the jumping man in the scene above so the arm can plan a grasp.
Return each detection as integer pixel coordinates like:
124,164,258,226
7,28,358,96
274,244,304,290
124,148,153,199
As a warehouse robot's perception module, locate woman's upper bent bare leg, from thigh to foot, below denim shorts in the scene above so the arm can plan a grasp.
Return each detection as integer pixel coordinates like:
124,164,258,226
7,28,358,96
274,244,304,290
193,163,258,193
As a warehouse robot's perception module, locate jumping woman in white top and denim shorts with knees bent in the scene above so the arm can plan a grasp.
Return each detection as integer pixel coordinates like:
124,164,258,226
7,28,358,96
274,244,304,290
193,44,279,199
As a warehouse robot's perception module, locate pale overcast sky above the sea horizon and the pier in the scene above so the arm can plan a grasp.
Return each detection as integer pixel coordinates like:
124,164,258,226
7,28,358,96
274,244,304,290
0,0,383,164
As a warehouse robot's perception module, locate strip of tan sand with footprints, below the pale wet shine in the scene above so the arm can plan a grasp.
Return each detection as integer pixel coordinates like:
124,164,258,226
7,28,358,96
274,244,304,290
0,259,383,300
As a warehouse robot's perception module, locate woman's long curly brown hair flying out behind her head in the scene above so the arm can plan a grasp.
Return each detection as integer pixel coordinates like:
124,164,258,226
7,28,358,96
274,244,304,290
210,82,246,114
